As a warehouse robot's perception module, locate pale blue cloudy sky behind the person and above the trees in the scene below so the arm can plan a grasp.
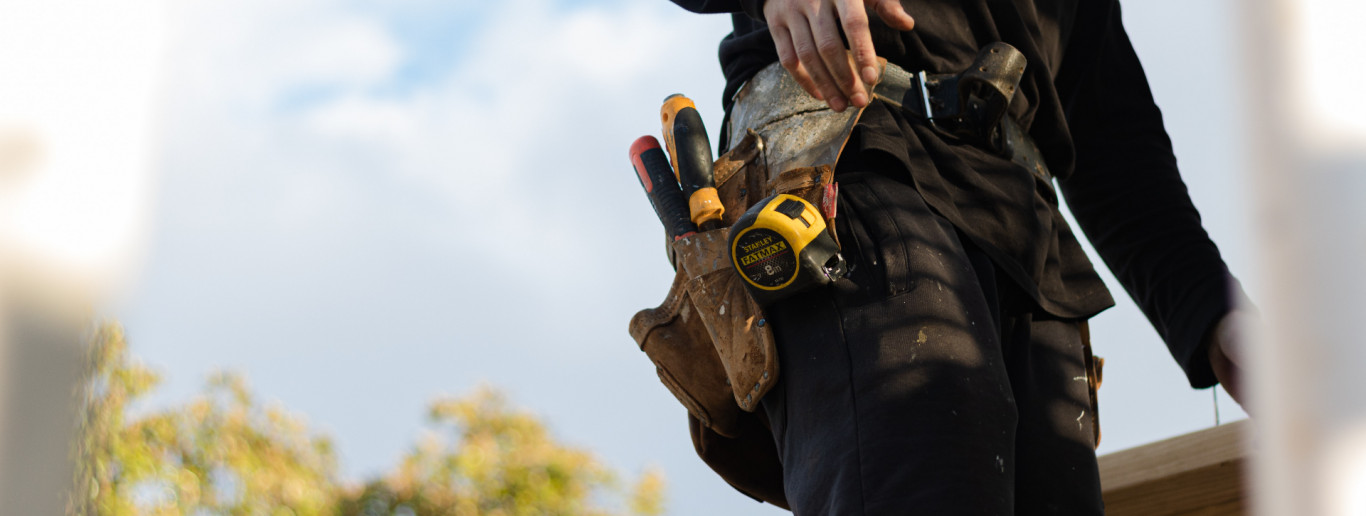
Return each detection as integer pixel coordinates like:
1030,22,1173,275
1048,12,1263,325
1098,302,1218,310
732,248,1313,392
77,0,1259,515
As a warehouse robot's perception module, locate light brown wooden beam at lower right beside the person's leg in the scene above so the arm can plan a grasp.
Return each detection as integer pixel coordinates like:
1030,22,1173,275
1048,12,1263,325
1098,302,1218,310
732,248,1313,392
1100,420,1249,516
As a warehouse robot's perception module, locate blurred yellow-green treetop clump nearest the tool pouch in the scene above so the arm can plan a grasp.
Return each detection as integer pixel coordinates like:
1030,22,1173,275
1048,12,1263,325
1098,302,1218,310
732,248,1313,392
340,388,663,516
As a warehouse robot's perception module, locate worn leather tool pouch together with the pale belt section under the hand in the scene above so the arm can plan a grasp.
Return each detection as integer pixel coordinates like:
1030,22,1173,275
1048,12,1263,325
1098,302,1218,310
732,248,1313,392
630,66,858,508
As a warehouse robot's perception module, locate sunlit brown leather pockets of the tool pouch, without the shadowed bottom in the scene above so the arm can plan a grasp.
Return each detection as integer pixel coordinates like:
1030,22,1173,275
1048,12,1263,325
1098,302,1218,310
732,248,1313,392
630,132,835,438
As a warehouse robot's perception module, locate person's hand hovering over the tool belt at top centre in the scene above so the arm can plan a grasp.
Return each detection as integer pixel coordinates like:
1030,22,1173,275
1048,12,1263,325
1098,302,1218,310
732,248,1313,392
764,0,915,111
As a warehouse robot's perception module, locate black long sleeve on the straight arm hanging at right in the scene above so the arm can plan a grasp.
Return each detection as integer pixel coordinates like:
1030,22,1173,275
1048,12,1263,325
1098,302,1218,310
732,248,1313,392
1060,4,1236,388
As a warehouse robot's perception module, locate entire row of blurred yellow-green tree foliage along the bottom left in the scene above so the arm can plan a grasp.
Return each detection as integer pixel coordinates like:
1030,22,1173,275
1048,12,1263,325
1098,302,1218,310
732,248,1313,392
68,325,664,516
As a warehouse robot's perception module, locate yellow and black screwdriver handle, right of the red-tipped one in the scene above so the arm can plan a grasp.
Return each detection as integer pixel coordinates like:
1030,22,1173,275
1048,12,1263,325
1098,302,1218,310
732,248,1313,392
660,93,725,231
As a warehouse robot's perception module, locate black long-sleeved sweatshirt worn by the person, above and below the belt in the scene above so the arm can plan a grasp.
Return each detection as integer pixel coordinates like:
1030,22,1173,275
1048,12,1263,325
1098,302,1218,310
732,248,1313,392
672,0,1240,388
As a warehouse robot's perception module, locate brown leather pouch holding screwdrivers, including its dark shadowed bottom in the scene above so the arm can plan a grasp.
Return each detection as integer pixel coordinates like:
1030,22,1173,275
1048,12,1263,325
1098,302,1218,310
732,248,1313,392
630,129,833,508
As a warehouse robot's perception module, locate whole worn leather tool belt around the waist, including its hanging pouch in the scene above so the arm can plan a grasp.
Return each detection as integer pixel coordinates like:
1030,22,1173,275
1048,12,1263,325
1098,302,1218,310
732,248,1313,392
630,44,1076,506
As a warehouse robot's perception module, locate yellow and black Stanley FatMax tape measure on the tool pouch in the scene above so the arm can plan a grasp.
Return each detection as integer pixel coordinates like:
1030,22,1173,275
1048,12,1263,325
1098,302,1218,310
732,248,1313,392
731,194,844,306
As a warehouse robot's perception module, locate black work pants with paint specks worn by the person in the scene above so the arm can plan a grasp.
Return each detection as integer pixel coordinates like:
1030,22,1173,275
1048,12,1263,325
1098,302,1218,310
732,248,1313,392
764,170,1104,515
